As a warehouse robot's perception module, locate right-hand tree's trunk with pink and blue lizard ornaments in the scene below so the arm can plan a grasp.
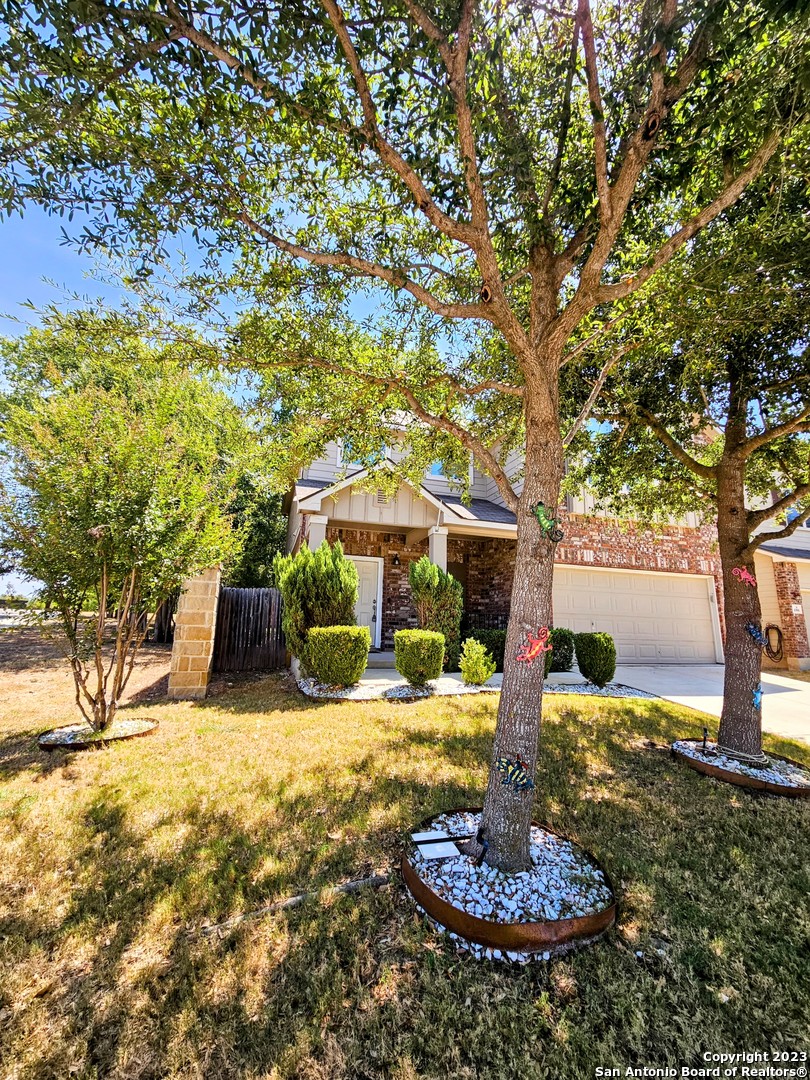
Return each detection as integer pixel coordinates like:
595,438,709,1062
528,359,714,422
717,460,762,758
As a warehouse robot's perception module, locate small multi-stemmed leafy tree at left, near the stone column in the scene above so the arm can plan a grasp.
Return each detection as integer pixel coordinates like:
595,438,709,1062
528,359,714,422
0,312,252,732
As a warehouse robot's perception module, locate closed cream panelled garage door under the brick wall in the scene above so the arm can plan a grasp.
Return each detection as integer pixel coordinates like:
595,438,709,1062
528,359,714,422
554,566,717,664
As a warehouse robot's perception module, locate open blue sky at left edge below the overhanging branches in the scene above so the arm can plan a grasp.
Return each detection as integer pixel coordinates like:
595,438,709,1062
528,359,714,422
0,200,123,595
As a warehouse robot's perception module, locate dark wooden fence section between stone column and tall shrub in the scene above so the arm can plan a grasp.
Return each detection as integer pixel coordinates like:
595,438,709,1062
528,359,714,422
214,589,286,672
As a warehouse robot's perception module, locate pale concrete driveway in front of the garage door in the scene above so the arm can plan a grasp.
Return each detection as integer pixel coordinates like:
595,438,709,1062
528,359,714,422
613,664,810,743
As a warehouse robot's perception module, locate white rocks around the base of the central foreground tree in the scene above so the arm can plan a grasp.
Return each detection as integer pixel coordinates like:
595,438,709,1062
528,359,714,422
409,812,615,963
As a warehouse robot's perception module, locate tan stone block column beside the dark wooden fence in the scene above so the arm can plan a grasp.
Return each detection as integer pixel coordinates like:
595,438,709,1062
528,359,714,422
168,566,220,701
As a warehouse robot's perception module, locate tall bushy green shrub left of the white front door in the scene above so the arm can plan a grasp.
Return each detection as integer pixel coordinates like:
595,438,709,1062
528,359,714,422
273,540,357,667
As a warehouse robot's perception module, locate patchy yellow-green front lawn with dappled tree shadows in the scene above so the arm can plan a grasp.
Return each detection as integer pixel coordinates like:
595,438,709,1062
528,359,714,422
0,677,810,1080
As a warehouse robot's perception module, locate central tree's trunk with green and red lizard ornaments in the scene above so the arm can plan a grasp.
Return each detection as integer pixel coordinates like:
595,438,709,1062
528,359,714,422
482,380,564,872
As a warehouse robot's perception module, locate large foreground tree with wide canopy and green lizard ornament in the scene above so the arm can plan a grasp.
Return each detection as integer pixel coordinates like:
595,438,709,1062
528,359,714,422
0,0,798,869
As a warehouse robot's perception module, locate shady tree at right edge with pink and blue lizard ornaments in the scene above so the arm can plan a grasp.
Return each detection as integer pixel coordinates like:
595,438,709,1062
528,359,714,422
568,181,810,759
